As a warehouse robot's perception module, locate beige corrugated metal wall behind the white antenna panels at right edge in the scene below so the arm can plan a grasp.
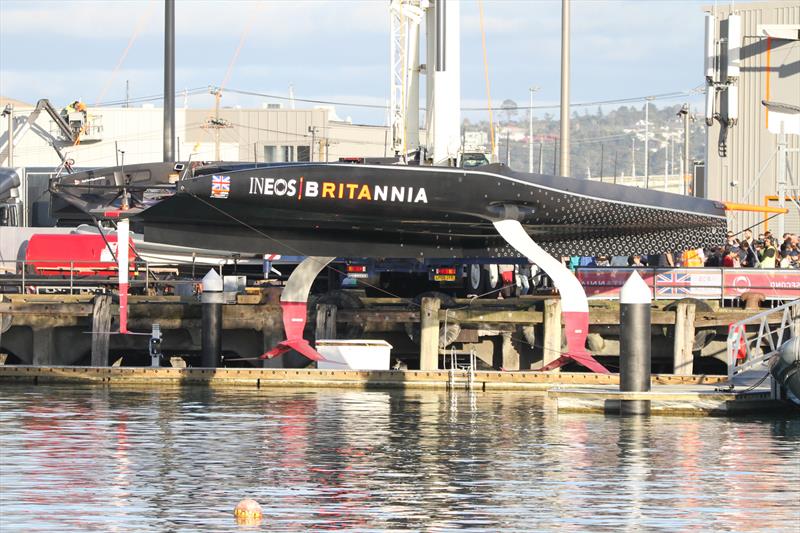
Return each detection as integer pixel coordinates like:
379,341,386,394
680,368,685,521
706,2,800,233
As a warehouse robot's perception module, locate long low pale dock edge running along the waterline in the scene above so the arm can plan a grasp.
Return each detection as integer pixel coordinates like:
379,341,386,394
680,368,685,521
0,365,800,416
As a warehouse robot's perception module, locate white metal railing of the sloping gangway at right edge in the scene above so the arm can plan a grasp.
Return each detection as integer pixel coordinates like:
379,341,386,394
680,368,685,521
728,299,800,385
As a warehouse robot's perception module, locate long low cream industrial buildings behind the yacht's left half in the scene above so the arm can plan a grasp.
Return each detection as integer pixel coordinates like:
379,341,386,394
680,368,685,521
0,99,391,168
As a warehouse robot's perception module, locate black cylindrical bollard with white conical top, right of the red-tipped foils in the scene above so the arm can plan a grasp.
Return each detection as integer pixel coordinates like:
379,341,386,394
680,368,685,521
619,270,652,415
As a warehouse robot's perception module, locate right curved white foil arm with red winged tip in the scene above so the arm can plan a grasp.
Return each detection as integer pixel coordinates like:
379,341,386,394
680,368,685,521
494,219,609,374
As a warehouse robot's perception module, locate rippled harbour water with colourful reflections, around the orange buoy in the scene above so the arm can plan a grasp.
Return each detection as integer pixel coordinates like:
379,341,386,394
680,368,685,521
0,386,800,532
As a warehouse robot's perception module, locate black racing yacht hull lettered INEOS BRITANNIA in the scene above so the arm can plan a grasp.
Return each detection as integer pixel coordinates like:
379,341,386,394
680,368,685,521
52,162,726,259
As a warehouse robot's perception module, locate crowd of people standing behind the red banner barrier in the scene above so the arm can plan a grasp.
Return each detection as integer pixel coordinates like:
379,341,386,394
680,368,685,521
563,229,800,270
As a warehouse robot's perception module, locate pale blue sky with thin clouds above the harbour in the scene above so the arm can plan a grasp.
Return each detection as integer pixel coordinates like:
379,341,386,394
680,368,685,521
0,0,720,124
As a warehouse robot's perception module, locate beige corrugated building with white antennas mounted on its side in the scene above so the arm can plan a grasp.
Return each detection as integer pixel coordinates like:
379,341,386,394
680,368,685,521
700,1,800,234
